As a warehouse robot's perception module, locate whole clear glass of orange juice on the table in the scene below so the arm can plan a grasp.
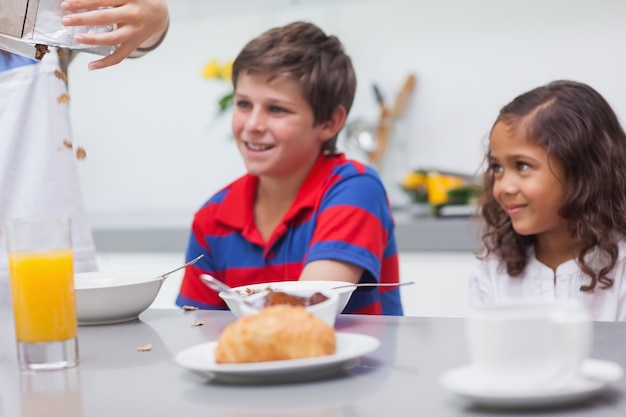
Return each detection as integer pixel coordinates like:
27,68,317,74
5,218,78,370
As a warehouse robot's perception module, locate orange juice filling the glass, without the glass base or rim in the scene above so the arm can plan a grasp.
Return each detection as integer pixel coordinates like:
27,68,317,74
9,249,77,343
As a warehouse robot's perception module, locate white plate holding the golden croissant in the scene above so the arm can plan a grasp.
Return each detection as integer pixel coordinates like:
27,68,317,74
174,332,380,383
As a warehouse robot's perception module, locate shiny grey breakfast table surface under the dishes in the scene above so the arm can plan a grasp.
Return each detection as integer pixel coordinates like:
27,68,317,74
0,309,626,417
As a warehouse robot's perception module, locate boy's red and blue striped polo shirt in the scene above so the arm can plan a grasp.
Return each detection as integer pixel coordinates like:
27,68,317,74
176,154,403,315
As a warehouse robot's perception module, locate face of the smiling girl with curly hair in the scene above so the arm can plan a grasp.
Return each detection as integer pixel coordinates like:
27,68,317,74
489,122,569,240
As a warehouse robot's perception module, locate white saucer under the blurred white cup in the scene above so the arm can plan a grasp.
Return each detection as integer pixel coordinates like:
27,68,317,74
439,359,623,408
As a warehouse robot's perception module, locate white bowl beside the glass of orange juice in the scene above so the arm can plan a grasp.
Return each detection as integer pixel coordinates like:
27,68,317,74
74,271,163,325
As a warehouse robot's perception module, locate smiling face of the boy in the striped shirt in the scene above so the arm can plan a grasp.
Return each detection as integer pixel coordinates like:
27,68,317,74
232,74,331,178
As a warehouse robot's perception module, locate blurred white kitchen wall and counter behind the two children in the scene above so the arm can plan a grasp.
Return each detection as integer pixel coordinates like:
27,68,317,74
69,0,626,316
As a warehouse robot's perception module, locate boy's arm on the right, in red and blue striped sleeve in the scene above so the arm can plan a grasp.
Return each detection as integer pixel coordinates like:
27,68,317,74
299,174,398,282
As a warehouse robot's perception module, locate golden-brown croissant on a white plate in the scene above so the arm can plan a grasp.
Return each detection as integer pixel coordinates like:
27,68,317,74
214,305,336,363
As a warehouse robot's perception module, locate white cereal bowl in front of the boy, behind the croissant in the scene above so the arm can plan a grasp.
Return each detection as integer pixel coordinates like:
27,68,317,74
219,281,356,324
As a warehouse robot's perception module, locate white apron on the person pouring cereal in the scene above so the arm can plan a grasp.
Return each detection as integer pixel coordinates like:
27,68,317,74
0,50,97,309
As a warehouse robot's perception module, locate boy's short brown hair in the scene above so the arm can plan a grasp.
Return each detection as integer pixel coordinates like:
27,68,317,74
232,22,356,154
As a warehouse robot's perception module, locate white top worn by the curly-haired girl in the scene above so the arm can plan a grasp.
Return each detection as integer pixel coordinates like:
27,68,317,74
469,239,626,321
